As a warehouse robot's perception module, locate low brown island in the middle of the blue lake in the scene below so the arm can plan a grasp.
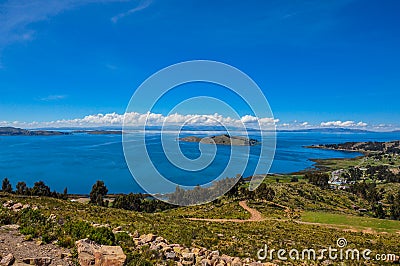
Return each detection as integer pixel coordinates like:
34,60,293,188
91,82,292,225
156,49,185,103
179,134,260,146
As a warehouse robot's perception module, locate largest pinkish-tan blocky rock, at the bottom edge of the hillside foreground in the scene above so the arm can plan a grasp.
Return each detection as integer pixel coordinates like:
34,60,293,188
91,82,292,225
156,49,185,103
75,239,126,266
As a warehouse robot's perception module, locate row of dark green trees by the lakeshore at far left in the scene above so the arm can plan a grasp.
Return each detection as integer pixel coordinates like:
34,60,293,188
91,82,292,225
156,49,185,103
1,178,68,199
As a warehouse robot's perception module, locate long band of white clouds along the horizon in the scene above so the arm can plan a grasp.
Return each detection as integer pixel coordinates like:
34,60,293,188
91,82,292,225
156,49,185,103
0,112,388,131
